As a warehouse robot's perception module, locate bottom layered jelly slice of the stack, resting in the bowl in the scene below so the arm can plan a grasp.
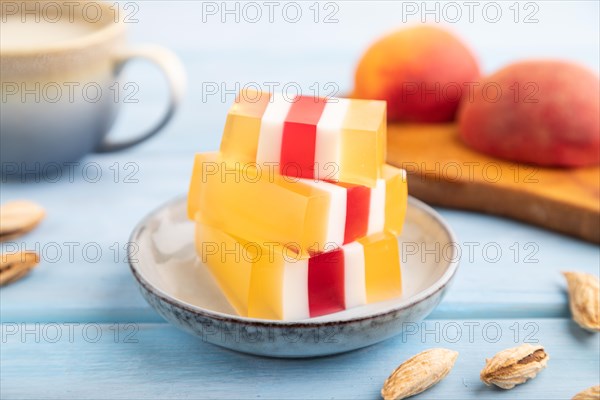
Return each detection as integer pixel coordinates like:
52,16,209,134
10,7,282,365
196,223,402,320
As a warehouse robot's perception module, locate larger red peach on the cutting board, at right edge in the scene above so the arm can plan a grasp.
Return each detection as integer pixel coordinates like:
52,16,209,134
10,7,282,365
459,61,600,167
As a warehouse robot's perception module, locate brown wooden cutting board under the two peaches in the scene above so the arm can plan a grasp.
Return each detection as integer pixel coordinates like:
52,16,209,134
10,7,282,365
387,124,600,243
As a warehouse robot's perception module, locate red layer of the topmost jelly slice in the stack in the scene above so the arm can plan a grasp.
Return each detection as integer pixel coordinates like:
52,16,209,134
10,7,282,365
280,96,325,179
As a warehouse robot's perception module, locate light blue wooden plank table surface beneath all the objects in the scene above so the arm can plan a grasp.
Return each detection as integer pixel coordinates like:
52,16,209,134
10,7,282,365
0,1,600,399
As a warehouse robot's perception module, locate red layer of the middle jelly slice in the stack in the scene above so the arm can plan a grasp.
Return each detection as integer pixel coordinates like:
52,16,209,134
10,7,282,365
338,183,371,244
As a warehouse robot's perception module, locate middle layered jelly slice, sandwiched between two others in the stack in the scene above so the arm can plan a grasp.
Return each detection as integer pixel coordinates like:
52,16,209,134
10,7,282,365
188,153,407,255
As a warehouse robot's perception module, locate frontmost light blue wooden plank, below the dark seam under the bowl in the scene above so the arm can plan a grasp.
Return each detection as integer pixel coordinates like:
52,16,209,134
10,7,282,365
0,319,600,400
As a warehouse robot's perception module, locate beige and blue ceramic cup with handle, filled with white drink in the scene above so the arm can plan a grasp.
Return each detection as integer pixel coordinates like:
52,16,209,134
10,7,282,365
0,0,185,174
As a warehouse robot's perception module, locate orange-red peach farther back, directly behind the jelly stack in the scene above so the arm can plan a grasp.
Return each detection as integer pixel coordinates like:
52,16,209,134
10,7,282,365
353,26,479,122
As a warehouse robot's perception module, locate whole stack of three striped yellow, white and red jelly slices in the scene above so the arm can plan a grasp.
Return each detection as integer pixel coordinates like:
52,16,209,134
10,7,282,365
188,91,407,320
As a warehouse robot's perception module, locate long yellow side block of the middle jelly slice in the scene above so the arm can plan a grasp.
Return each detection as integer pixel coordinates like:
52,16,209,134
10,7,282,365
188,153,330,254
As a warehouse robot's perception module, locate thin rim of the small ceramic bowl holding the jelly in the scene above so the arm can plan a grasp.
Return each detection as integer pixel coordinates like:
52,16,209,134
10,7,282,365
127,195,459,328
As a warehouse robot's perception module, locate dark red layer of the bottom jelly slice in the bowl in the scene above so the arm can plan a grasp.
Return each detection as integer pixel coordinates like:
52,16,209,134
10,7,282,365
308,249,346,317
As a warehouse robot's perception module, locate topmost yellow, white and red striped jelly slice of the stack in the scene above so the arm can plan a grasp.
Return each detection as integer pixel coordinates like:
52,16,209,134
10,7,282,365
221,90,386,187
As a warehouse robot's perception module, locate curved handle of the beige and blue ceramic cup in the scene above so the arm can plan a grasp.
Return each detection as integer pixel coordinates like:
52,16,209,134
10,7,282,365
96,45,186,153
